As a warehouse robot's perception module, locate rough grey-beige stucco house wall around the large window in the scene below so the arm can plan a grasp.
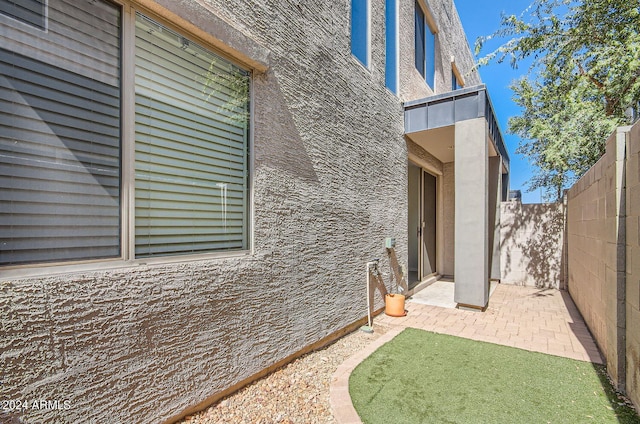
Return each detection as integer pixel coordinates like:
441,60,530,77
0,0,480,423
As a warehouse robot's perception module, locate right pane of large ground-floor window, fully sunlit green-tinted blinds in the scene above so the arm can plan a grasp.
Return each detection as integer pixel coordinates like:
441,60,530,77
135,14,249,257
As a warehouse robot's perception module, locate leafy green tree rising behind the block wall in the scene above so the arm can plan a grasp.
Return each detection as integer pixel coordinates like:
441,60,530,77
476,0,640,197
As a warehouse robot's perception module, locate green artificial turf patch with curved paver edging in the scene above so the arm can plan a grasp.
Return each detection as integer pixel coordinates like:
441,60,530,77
349,328,640,424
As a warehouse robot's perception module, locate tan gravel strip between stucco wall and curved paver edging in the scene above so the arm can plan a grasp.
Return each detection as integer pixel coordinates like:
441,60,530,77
181,326,386,424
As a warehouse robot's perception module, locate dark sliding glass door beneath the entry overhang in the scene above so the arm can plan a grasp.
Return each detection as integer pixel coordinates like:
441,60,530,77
408,162,438,289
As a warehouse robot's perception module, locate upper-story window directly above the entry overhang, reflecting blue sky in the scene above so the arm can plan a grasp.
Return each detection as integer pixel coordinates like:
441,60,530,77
415,1,436,89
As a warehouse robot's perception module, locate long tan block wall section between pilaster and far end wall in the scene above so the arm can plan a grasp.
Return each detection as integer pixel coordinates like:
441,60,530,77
567,128,618,388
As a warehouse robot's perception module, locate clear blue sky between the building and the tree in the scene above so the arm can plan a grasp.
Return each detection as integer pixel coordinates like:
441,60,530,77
454,0,541,203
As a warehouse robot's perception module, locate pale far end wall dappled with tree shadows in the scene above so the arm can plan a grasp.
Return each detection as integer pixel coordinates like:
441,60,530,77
500,202,564,288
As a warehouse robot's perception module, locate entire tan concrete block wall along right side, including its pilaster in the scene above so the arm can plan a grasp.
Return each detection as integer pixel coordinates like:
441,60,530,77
566,124,640,406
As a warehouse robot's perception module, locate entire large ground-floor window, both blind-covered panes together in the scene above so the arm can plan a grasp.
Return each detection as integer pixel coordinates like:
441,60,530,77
0,0,249,266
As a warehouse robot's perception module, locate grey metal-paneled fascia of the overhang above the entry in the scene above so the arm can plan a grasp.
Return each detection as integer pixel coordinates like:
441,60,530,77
404,84,509,172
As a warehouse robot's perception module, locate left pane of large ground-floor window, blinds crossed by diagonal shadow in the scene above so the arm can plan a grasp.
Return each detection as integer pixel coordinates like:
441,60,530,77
0,0,121,265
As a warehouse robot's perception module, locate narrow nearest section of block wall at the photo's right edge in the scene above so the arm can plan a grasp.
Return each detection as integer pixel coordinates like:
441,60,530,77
625,124,640,410
